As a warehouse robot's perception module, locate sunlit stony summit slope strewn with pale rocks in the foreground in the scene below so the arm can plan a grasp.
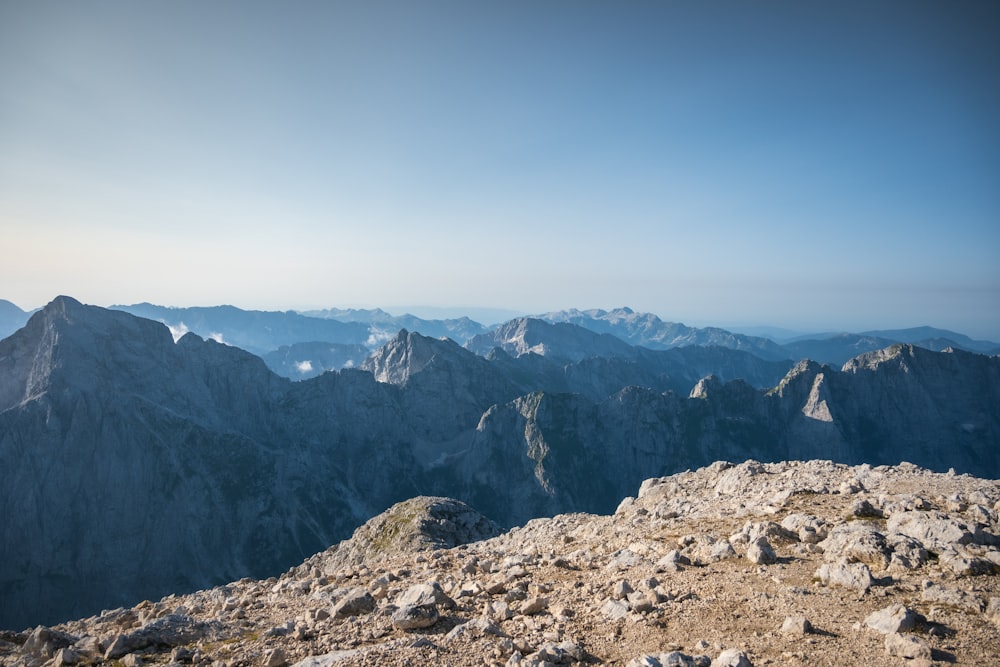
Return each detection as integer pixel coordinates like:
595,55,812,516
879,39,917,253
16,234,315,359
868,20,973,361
0,461,1000,667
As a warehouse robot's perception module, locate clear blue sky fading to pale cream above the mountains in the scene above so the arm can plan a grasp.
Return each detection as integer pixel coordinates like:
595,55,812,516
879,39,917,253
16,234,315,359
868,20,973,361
0,0,1000,340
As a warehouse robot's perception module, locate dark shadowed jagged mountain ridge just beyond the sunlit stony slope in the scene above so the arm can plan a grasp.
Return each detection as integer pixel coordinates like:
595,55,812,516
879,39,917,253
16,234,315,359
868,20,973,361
0,297,1000,627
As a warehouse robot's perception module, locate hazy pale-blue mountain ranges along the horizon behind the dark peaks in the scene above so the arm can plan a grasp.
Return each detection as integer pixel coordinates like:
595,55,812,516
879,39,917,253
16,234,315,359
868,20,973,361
0,300,1000,380
